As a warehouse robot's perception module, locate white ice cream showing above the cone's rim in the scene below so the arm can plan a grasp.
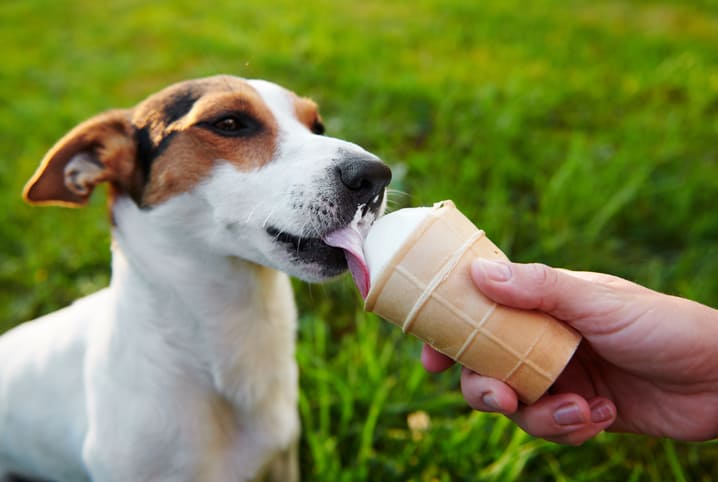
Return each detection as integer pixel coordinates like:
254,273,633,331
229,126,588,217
364,207,433,286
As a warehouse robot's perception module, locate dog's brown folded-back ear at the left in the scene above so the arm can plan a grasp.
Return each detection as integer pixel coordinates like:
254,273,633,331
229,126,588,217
23,110,142,207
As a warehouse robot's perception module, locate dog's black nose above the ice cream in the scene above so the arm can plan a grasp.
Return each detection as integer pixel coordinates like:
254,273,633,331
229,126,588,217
337,159,391,204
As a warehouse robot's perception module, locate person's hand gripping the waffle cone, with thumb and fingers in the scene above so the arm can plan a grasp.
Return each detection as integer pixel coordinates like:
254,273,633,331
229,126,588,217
422,259,718,445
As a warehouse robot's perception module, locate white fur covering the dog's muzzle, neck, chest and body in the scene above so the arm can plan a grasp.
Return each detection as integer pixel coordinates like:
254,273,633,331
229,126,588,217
0,77,388,482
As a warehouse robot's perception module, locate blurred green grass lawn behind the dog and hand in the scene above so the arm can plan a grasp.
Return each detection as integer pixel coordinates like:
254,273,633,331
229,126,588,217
0,0,718,481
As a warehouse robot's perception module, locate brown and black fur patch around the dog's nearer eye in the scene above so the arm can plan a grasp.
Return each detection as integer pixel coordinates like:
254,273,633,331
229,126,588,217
135,77,279,206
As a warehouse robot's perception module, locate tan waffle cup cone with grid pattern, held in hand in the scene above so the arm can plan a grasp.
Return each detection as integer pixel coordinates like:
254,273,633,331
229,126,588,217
366,201,581,404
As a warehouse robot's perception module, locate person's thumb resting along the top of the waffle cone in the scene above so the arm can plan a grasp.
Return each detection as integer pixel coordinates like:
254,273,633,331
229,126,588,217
471,258,624,331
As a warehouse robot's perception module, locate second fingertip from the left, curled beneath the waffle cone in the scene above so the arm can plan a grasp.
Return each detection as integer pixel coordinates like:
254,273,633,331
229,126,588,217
461,368,519,414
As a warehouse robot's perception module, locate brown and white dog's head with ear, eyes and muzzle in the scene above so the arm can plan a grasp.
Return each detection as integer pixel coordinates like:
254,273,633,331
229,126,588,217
24,76,391,281
